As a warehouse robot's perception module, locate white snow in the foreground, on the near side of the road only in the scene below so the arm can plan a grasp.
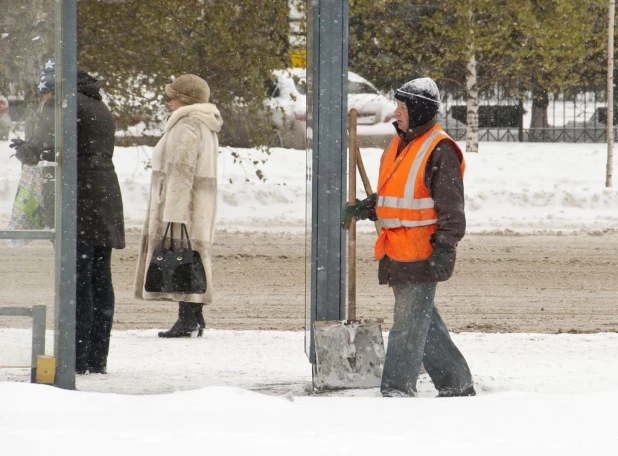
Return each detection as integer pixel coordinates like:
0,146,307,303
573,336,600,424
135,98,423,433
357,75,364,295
0,329,618,456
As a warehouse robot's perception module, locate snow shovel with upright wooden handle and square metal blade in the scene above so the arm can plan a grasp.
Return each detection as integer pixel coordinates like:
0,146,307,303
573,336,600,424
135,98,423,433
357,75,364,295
313,109,384,391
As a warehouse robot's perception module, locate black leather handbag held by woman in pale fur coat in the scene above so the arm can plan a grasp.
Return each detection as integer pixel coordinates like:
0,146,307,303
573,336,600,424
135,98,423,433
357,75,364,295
144,223,206,294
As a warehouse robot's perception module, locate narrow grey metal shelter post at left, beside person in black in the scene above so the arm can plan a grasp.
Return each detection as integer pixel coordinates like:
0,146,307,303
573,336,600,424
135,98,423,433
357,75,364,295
54,0,77,389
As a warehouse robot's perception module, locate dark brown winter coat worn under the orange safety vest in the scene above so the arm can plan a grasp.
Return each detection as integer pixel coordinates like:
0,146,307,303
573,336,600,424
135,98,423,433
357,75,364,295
368,121,466,286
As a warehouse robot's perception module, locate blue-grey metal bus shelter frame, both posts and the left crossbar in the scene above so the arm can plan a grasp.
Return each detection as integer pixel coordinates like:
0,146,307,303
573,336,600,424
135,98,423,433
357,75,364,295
0,0,348,389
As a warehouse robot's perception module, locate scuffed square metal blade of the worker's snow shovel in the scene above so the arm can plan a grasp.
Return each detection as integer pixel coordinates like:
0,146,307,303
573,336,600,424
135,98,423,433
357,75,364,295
313,321,384,391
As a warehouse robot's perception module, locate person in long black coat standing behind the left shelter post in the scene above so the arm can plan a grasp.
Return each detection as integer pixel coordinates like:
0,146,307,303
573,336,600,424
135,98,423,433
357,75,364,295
11,59,125,374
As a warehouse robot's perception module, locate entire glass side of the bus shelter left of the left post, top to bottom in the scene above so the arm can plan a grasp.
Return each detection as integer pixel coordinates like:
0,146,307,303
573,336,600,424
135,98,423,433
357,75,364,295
0,0,62,379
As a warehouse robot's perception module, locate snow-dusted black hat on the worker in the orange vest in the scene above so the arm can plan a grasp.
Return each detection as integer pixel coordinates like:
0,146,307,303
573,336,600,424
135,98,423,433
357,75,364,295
395,78,440,128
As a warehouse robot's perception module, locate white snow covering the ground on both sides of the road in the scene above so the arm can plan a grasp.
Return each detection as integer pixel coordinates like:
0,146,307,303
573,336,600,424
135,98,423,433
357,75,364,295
0,136,618,456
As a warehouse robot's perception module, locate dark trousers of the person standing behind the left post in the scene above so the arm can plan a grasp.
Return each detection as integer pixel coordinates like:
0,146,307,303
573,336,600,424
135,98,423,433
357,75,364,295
75,241,115,372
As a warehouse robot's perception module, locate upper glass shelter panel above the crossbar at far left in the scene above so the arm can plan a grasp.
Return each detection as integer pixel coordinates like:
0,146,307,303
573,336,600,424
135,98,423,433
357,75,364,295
0,0,56,235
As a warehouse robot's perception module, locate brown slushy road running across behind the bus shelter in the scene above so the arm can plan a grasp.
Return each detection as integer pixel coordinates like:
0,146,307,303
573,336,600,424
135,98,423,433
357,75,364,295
0,230,618,333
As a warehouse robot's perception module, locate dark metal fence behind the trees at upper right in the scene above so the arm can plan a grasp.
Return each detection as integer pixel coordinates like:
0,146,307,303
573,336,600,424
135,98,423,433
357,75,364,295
440,89,618,143
